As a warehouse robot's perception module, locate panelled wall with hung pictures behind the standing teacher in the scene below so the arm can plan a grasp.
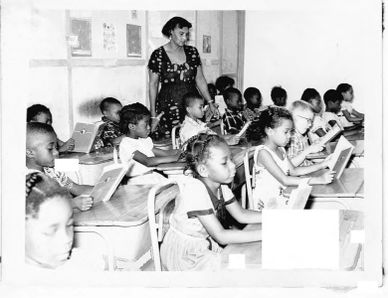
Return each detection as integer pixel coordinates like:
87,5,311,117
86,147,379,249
27,9,233,140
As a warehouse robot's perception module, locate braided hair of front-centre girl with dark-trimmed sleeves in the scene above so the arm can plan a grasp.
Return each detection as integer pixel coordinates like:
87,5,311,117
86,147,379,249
184,133,226,178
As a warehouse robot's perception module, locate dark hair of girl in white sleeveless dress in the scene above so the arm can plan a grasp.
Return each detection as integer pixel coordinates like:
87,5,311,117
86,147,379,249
246,106,292,142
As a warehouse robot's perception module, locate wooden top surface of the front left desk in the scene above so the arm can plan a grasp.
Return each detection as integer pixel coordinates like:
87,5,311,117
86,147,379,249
74,185,179,227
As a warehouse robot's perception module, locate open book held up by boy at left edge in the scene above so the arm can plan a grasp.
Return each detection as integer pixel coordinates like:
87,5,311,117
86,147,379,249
90,163,129,203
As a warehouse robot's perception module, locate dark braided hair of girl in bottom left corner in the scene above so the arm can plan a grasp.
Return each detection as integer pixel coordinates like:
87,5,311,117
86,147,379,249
26,172,71,218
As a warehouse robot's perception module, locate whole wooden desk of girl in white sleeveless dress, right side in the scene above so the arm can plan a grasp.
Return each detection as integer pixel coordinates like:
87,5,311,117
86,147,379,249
284,168,365,211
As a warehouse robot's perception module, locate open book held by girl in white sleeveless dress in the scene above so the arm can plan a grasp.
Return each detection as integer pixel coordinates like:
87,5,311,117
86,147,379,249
329,136,354,179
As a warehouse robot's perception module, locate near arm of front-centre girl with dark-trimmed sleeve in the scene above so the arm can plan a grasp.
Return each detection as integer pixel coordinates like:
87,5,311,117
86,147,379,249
198,213,261,245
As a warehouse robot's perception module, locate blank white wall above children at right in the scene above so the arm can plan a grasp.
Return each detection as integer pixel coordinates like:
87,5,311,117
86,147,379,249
244,6,376,111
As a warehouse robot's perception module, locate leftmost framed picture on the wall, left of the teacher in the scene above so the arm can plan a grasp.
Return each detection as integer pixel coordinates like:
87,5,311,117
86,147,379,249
70,18,92,57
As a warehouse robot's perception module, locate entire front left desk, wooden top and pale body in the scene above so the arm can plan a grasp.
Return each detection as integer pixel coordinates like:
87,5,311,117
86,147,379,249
74,185,179,269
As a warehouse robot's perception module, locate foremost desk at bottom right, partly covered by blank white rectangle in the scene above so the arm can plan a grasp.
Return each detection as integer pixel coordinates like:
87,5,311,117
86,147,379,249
222,210,364,270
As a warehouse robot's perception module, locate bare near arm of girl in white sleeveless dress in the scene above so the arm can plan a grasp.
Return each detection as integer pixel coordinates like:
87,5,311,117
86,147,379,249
257,150,334,187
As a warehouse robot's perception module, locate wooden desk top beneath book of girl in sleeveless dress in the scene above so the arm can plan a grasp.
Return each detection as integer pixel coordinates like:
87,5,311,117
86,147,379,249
285,168,364,198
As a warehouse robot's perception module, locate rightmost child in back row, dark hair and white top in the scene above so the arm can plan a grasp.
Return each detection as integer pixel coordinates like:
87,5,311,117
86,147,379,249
337,83,364,127
